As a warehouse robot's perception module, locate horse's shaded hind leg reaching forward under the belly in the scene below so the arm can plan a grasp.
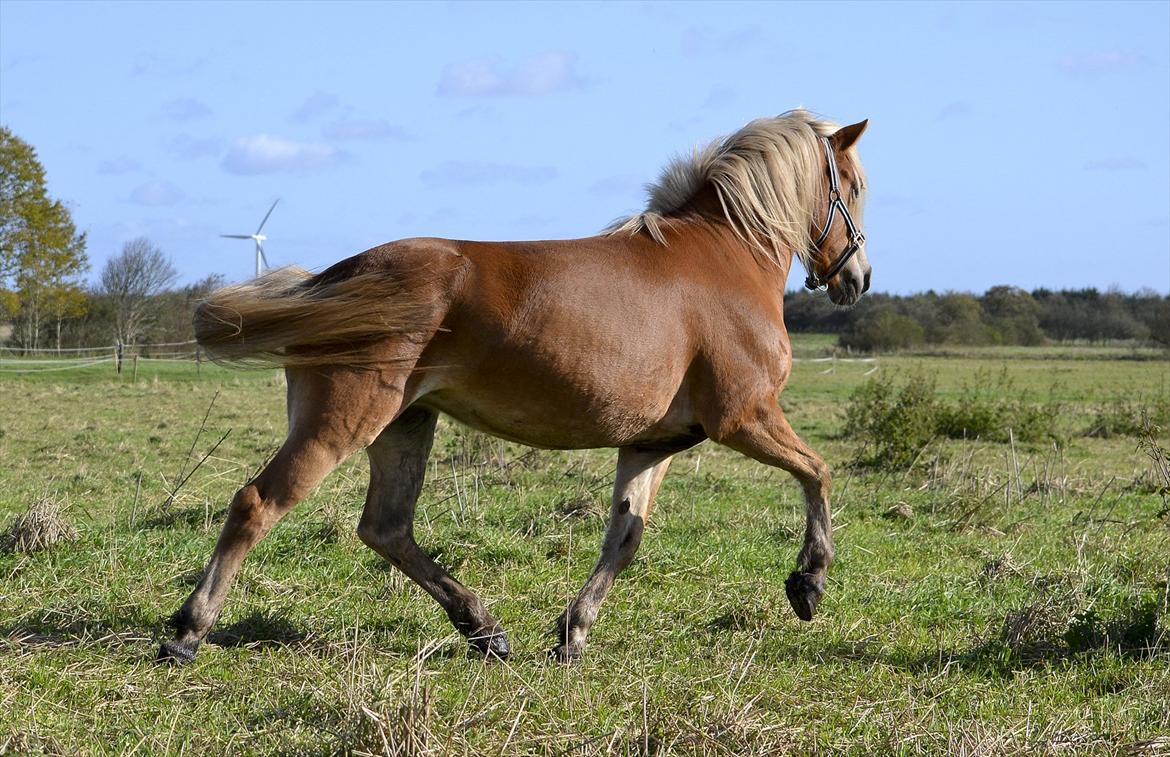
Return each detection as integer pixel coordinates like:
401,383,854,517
358,407,509,658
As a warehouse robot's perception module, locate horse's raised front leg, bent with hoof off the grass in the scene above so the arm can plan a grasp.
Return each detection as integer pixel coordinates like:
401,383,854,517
717,399,834,620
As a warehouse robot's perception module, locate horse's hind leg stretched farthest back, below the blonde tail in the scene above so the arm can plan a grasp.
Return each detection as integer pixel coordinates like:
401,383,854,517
158,369,401,662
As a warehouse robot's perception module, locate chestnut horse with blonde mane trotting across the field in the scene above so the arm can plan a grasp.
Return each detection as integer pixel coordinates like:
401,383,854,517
158,110,870,663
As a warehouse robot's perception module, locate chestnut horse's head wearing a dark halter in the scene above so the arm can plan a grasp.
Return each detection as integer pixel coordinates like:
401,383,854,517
805,119,873,305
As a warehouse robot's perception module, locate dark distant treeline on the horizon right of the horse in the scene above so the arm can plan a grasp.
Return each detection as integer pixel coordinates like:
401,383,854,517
784,287,1170,352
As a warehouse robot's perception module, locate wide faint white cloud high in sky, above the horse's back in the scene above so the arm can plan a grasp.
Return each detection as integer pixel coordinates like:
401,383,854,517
436,53,586,97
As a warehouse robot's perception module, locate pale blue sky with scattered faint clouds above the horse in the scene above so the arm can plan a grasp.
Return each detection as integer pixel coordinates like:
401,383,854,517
0,0,1170,293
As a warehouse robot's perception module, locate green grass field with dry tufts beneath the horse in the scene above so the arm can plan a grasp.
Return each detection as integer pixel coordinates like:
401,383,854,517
0,338,1170,755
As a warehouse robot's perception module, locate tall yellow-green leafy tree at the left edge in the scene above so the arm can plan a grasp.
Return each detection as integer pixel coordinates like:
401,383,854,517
0,126,89,347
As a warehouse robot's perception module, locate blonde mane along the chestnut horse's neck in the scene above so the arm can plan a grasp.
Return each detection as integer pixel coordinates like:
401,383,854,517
605,109,860,268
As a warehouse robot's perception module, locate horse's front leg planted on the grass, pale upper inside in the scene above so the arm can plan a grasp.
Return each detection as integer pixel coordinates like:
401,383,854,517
552,447,672,662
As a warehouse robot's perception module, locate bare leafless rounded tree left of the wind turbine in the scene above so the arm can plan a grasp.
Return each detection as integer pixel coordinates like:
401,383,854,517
99,236,178,344
